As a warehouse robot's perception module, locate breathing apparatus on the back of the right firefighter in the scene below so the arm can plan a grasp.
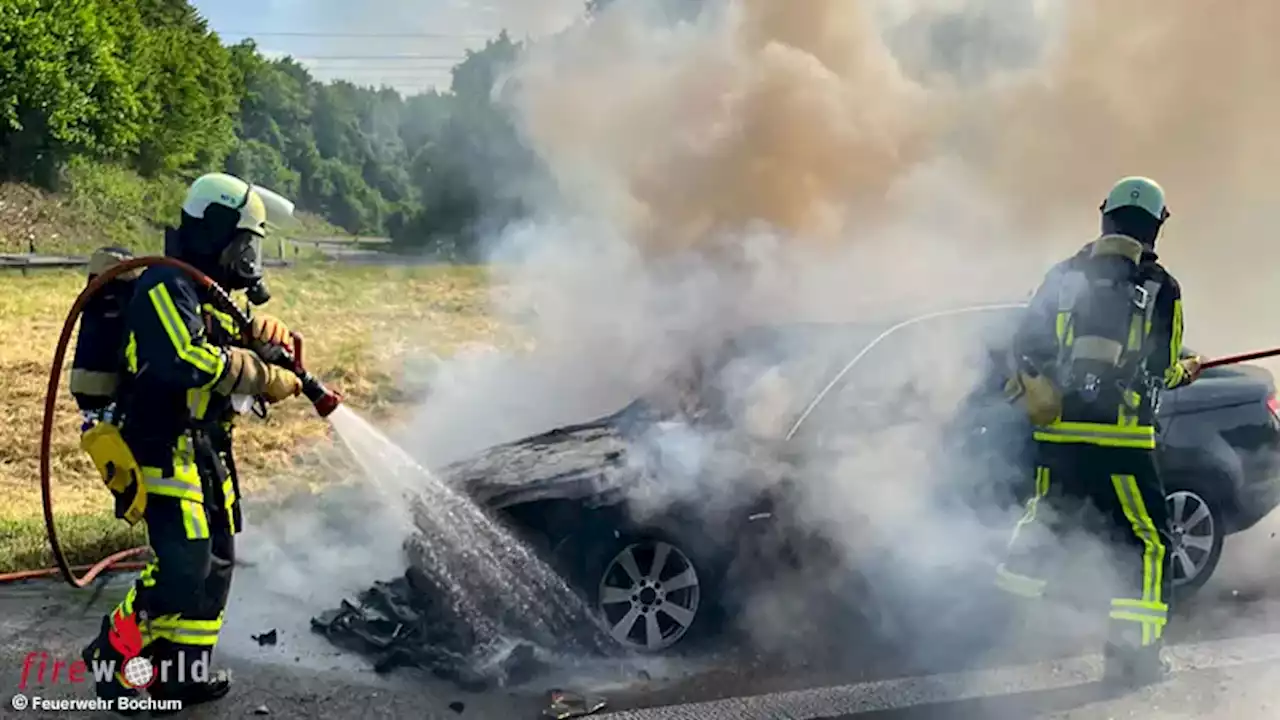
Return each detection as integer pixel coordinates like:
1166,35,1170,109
1006,234,1161,425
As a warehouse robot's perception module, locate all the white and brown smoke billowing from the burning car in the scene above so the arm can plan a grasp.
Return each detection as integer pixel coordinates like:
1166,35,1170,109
240,0,1280,681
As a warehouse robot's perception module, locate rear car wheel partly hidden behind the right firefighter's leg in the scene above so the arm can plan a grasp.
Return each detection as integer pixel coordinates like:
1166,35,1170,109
1166,486,1226,597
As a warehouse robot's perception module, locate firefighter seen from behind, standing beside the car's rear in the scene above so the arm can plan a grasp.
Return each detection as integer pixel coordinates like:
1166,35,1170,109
997,177,1201,687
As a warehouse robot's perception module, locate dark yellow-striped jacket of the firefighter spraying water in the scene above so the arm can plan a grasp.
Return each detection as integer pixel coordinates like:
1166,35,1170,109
120,260,241,532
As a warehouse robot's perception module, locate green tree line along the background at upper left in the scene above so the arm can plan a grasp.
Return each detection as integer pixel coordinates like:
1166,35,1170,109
0,0,606,255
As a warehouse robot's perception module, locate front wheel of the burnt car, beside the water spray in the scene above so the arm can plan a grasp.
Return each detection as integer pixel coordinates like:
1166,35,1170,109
589,534,708,653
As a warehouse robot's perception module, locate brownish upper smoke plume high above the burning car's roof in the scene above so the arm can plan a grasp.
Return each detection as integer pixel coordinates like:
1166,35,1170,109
504,0,1280,340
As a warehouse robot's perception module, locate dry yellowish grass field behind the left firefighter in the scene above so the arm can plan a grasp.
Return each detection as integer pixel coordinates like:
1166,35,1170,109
0,260,509,571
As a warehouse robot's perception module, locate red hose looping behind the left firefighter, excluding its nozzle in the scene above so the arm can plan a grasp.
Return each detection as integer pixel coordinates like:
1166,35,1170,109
0,256,235,588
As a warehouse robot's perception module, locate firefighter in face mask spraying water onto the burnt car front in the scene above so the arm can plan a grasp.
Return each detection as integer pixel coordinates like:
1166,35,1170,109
80,173,301,706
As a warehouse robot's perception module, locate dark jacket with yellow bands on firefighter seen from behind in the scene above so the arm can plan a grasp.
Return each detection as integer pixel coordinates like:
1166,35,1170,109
1014,238,1192,448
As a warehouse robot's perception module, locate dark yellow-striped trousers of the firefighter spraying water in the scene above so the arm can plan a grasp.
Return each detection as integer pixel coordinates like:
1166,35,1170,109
86,481,236,694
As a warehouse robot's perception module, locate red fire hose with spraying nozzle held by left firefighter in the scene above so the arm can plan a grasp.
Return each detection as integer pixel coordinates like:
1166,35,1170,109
0,256,342,588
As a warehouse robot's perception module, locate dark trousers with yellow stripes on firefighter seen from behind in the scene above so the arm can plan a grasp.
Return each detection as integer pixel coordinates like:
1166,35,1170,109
996,442,1172,650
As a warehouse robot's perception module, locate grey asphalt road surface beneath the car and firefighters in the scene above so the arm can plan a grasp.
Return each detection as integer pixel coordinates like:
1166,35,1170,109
0,504,1280,720
